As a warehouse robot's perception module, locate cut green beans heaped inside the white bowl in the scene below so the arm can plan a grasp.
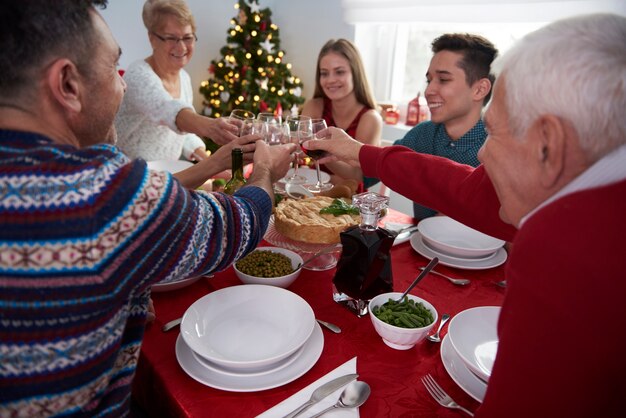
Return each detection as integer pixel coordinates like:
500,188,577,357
372,296,434,328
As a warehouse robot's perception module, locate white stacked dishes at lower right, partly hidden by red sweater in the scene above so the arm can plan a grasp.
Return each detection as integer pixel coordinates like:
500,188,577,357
441,306,500,402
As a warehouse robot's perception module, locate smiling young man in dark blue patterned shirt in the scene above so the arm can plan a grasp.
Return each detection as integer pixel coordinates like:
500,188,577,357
365,34,498,220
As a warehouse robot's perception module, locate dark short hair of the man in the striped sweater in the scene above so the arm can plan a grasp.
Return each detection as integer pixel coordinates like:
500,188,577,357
0,0,107,100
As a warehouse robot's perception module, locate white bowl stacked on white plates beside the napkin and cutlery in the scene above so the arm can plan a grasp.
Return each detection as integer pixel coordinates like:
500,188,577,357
176,285,324,392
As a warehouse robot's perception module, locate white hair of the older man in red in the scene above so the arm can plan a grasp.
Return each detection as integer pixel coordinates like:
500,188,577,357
493,14,626,161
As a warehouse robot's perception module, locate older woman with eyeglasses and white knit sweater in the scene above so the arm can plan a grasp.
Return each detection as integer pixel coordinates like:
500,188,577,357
115,0,237,161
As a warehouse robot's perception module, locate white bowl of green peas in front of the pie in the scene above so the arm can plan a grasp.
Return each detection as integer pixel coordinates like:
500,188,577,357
233,247,303,288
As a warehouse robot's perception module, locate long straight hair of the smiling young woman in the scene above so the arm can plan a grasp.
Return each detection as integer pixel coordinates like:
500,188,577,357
313,39,376,109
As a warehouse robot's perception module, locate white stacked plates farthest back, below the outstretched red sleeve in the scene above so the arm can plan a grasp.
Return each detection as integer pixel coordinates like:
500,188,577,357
411,216,507,270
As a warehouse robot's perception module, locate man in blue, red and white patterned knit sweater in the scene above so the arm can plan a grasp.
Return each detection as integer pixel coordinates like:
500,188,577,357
0,0,295,417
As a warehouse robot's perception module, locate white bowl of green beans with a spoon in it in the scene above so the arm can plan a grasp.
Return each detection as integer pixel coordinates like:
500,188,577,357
369,292,438,350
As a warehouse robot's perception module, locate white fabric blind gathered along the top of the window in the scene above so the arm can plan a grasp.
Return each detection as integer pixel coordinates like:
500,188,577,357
342,0,626,24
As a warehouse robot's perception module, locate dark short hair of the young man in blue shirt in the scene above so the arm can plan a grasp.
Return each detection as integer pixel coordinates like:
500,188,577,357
432,33,498,103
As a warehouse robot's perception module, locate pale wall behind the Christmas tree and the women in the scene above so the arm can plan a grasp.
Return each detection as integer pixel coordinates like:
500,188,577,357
101,0,354,110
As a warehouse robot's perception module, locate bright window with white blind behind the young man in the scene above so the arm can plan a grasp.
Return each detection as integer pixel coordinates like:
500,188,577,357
342,0,626,104
